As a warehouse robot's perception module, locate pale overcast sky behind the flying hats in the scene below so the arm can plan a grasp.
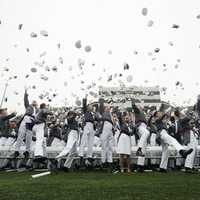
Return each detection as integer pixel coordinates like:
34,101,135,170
0,0,200,110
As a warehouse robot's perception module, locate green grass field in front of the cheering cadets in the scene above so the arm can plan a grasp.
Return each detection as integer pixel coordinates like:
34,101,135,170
0,172,200,200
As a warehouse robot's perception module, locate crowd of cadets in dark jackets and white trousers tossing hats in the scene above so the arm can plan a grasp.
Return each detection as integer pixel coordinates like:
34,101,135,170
0,90,200,173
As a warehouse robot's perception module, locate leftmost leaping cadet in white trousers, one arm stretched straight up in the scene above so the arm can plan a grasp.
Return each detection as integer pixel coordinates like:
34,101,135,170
14,89,38,158
